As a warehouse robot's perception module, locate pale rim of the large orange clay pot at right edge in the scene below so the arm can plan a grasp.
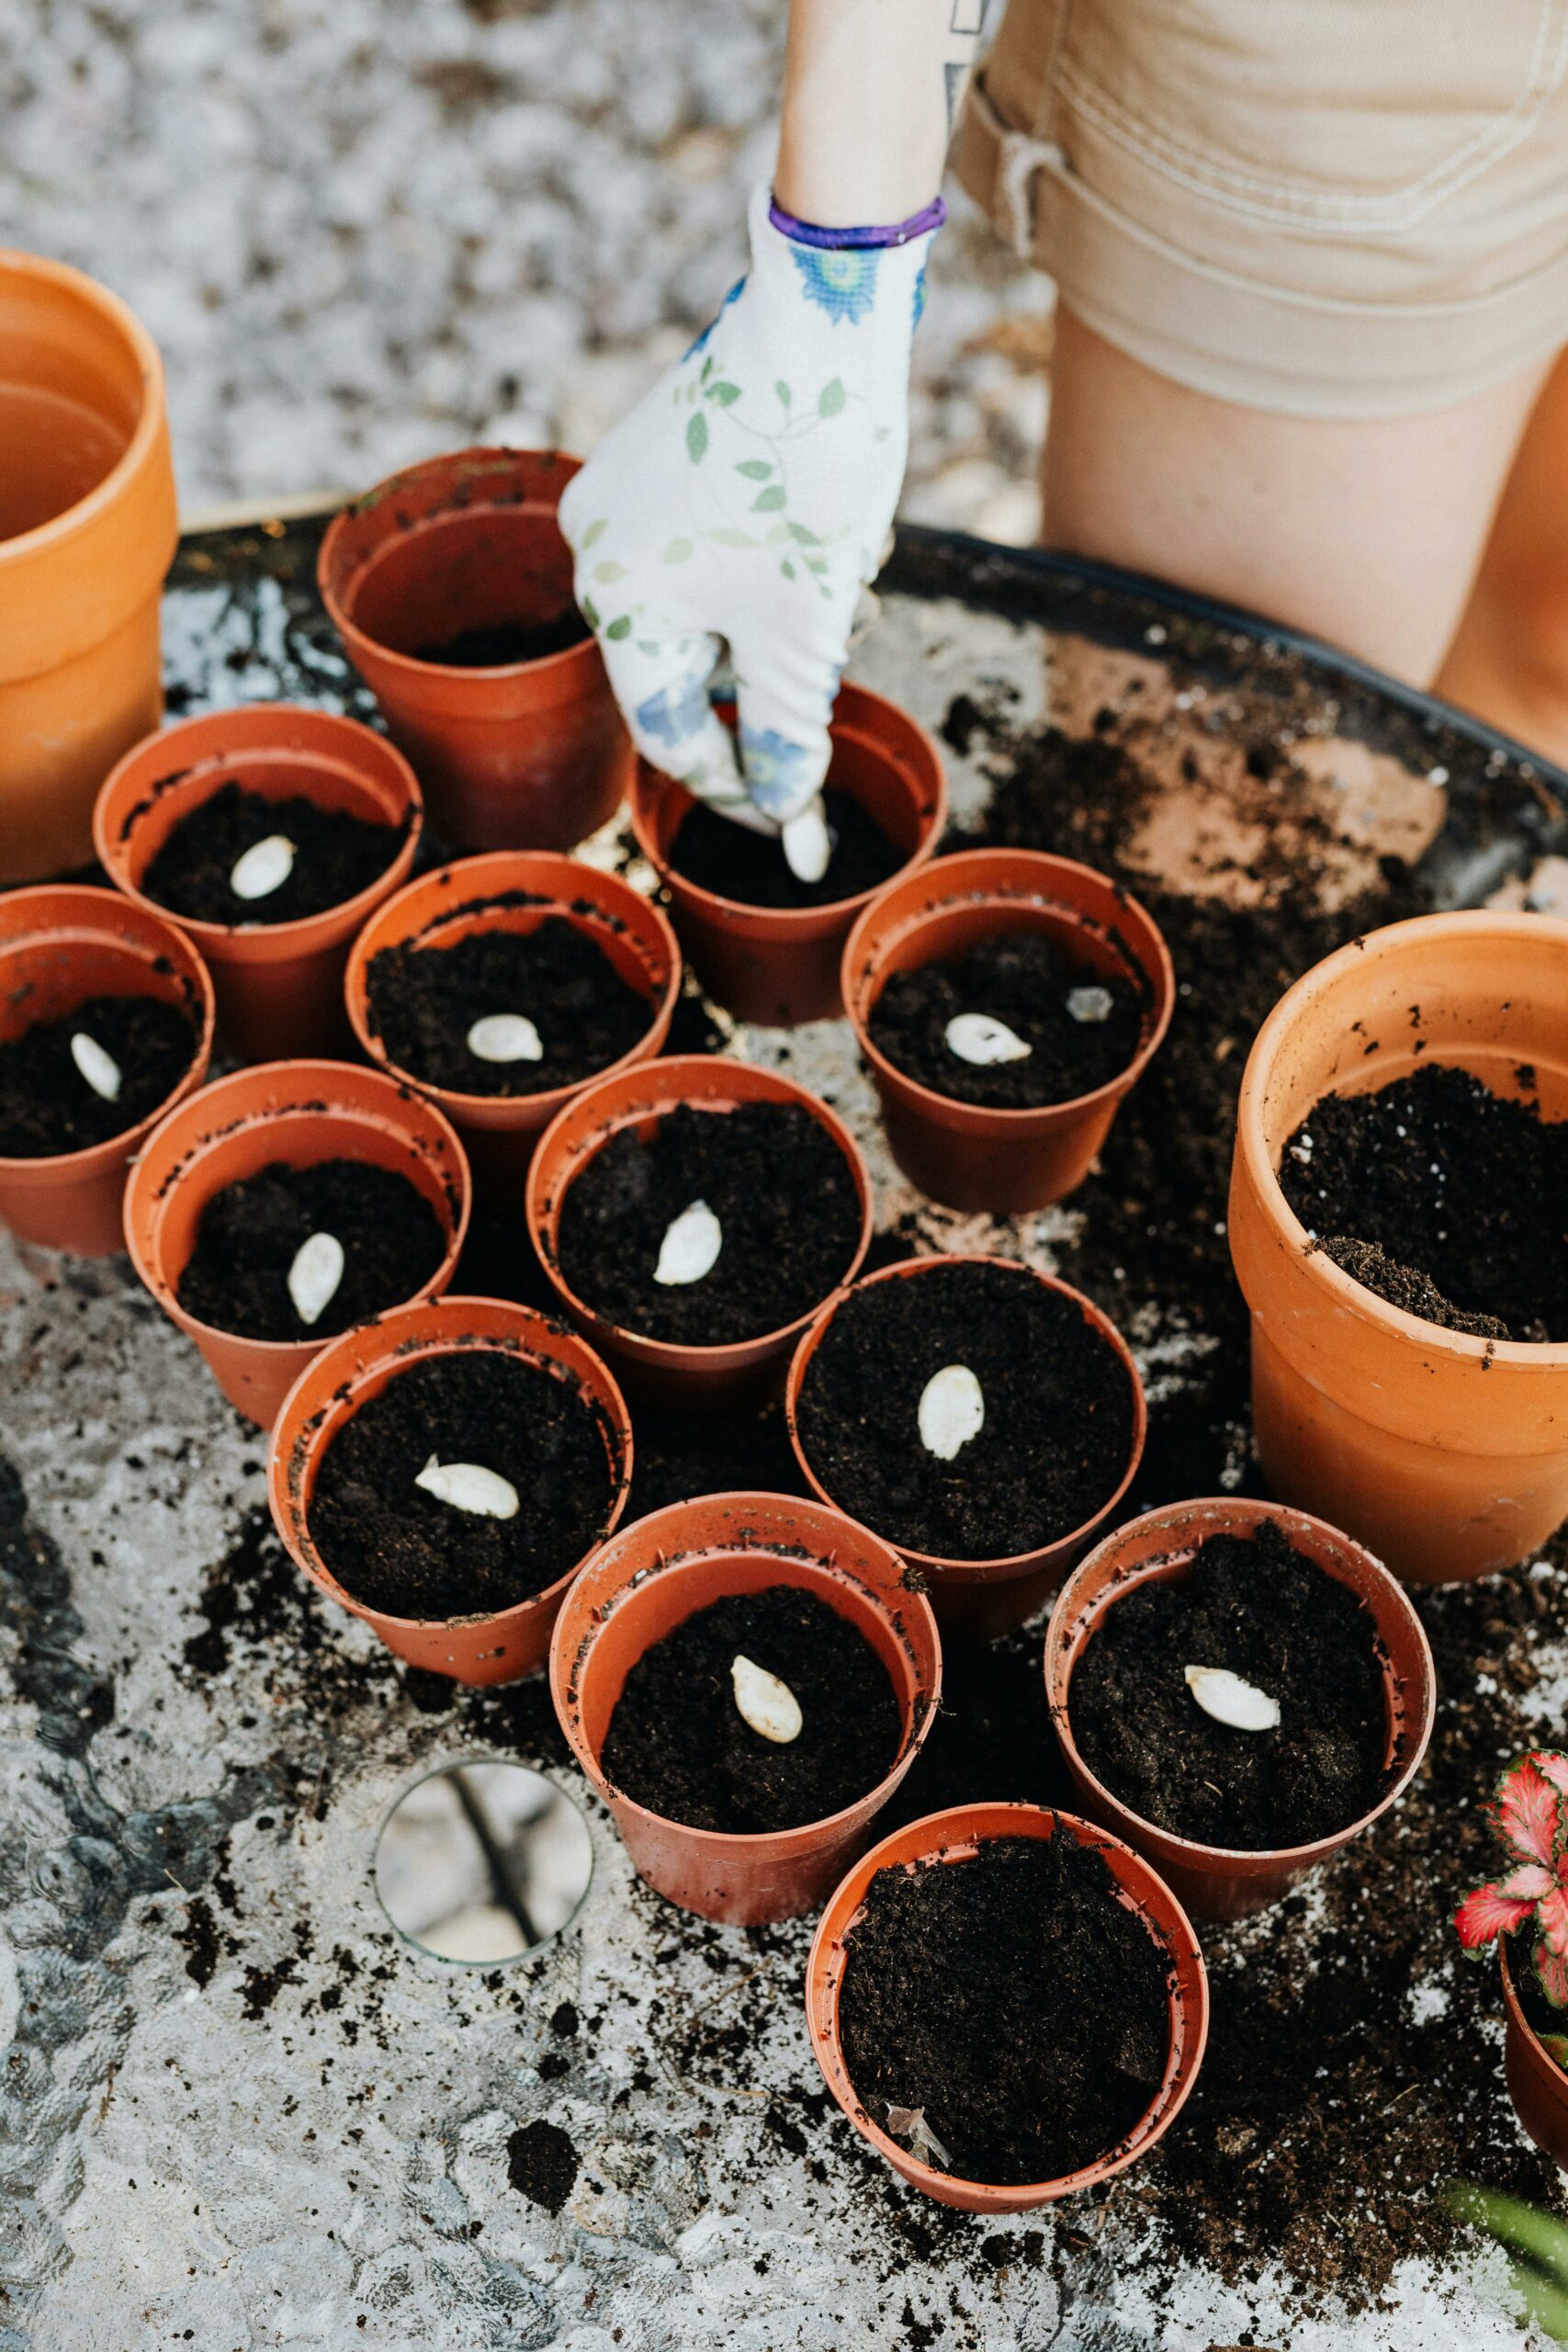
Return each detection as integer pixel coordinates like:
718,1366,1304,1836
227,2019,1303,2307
1236,908,1568,1371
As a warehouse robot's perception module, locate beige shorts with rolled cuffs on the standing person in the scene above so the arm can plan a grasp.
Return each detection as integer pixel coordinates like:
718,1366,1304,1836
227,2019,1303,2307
957,0,1568,416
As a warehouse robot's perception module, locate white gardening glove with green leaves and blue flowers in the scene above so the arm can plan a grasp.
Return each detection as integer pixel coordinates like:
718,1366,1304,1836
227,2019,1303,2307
559,174,942,882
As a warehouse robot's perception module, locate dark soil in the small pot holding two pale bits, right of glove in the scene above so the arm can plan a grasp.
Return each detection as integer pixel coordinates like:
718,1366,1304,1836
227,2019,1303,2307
867,932,1145,1110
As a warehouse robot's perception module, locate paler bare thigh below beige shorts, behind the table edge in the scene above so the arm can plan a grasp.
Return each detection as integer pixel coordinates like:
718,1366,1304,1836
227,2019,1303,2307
1043,308,1541,686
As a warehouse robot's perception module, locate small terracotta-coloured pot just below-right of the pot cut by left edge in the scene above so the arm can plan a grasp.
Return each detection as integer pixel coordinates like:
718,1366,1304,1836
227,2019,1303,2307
125,1061,470,1430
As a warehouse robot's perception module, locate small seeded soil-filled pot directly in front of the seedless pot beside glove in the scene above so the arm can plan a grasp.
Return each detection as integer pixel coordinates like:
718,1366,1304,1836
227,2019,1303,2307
345,849,682,1188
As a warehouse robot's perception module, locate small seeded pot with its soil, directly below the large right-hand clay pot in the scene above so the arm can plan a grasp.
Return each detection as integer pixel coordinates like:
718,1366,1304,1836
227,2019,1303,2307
1046,1498,1437,1919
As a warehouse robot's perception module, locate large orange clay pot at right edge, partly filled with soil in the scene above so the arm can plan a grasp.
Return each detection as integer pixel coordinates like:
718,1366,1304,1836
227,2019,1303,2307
1229,912,1568,1585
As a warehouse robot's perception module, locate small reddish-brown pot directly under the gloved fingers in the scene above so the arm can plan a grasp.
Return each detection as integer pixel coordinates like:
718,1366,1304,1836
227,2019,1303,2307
632,687,947,1028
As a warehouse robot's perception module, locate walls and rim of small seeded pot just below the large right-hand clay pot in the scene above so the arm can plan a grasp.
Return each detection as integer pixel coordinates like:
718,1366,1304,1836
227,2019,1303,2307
1046,1496,1437,1919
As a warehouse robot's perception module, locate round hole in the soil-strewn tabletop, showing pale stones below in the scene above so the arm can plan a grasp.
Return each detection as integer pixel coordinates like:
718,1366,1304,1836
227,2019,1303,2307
374,1759,592,1969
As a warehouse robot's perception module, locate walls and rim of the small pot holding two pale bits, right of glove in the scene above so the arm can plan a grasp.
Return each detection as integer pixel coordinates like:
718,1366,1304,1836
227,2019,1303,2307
841,849,1176,1216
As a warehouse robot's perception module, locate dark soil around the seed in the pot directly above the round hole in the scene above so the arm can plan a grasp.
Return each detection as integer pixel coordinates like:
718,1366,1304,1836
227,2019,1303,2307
310,1348,614,1621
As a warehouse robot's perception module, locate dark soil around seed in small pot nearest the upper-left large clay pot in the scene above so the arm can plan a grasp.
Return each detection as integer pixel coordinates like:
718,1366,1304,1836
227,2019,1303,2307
141,776,407,924
